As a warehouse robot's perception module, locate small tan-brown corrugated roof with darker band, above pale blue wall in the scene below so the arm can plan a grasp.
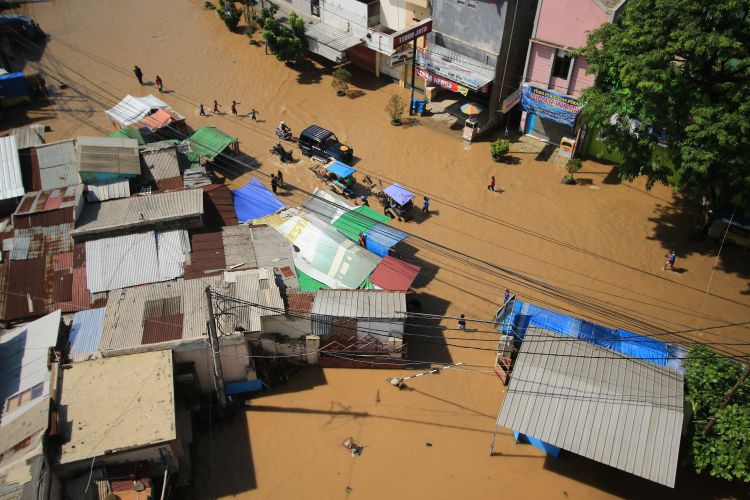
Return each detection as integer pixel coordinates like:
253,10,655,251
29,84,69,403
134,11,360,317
76,137,141,175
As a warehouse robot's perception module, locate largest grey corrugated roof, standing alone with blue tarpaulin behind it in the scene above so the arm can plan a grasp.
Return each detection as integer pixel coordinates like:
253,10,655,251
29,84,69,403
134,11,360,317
497,328,684,487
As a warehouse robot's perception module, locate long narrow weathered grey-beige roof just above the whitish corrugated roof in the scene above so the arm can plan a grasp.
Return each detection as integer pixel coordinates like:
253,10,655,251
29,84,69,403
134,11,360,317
73,189,203,238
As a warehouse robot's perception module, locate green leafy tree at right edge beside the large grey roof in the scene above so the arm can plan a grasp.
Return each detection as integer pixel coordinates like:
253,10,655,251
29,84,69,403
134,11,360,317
685,345,750,482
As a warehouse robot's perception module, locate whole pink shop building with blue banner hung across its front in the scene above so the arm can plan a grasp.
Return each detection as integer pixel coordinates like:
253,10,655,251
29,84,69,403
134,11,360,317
519,0,625,147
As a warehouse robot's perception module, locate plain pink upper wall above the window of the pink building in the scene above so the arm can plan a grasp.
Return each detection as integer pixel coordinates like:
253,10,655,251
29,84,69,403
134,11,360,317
534,0,611,48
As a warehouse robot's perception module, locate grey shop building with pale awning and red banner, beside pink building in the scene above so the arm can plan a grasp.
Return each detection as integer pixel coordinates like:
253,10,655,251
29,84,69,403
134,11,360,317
424,0,536,124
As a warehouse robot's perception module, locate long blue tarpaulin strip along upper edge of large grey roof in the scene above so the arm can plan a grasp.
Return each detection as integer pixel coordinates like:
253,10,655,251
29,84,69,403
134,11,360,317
505,300,687,370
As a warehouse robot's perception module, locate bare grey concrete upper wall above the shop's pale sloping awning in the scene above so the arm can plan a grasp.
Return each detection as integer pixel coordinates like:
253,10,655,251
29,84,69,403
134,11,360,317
430,0,508,59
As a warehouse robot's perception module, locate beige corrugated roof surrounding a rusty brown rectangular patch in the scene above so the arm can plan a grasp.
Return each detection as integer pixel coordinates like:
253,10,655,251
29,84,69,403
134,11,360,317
99,276,229,351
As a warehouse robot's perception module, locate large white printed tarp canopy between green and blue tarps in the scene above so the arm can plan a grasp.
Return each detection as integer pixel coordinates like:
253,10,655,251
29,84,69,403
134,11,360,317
254,208,381,289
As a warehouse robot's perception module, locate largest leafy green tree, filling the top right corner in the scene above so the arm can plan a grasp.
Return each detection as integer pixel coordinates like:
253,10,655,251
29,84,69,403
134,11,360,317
579,0,750,205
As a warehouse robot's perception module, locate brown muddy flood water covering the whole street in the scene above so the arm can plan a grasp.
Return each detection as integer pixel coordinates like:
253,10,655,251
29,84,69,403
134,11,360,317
8,0,750,499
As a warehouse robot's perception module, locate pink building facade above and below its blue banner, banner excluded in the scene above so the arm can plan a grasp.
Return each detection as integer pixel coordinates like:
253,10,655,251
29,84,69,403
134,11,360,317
521,0,625,144
